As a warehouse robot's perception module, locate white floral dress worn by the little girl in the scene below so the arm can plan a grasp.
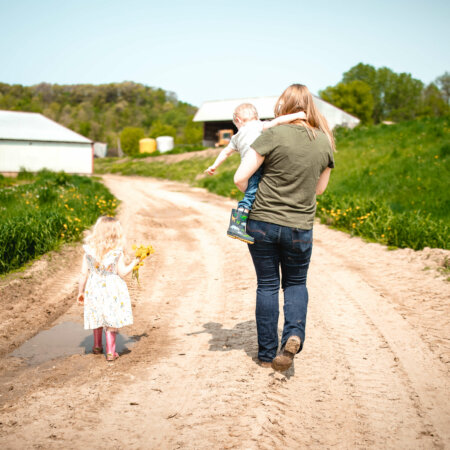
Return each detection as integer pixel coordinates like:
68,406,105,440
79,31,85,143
83,245,133,330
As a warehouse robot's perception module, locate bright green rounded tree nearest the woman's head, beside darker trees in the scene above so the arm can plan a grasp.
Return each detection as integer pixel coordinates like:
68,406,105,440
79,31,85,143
319,80,374,124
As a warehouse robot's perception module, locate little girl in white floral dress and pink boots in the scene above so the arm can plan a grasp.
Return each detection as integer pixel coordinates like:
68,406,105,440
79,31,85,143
77,216,139,361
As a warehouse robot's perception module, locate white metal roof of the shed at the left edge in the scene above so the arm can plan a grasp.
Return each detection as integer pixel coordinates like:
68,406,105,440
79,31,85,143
0,111,92,144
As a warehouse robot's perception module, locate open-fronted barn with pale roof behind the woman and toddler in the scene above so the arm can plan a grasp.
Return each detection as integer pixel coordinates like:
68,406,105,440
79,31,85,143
194,96,360,147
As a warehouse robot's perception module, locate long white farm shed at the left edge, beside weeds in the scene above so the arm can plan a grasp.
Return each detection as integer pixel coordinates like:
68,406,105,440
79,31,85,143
0,111,94,174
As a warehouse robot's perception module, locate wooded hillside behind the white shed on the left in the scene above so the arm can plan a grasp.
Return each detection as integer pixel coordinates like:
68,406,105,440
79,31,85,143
0,81,202,153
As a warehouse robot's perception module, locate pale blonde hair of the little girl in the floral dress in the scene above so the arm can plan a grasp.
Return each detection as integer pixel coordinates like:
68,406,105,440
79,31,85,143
86,216,122,261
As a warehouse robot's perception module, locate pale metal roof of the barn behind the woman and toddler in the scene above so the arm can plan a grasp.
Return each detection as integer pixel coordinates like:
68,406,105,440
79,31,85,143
194,96,360,128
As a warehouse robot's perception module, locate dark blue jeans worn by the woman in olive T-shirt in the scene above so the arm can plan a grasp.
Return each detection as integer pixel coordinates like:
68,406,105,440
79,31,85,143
247,219,313,361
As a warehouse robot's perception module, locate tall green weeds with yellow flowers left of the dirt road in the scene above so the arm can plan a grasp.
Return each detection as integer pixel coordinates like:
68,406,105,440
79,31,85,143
0,171,117,274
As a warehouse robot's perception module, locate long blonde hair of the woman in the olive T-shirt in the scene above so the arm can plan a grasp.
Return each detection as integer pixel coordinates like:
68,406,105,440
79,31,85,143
274,84,336,150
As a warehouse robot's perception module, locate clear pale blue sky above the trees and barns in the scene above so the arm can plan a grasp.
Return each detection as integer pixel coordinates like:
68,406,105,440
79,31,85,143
0,0,450,106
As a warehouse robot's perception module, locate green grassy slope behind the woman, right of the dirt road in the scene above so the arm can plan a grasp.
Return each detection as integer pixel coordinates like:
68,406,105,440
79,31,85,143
95,117,450,250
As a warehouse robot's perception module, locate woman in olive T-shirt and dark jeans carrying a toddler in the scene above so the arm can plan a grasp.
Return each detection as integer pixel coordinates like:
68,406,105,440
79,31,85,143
234,84,334,371
